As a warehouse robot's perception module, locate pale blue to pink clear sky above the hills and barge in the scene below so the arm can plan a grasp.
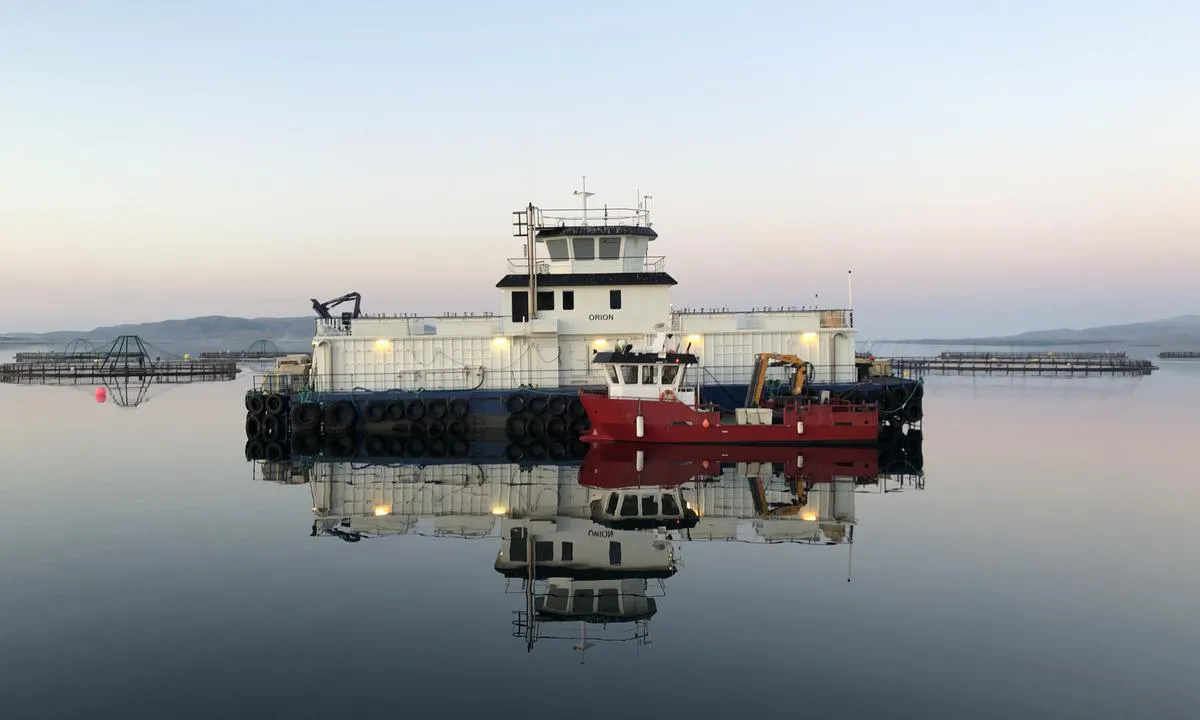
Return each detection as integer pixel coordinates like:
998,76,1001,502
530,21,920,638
0,0,1200,338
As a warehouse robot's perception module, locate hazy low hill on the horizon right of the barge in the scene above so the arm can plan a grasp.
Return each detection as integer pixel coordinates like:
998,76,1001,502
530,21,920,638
892,314,1200,349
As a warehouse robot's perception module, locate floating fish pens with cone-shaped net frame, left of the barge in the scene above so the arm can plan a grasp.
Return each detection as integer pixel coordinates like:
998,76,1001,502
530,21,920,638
0,335,239,385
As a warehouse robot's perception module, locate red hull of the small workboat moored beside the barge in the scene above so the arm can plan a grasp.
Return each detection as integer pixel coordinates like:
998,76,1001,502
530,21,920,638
580,392,880,445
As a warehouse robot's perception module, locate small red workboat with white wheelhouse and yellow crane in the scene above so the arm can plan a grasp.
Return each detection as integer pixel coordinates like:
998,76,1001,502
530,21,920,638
580,346,878,445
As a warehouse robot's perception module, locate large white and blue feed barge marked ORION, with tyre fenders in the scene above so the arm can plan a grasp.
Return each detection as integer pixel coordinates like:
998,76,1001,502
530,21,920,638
246,199,922,437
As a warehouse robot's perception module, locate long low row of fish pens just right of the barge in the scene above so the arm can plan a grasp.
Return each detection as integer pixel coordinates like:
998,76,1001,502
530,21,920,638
890,352,1158,376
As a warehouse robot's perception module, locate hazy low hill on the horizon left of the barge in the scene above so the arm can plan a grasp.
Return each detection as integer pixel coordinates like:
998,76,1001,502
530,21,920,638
0,316,317,354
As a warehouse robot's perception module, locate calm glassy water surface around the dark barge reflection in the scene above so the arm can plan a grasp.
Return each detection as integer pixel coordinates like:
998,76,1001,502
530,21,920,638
0,350,1200,718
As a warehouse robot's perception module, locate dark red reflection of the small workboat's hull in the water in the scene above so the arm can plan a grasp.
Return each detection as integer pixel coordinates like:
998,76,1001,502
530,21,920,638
580,443,880,488
